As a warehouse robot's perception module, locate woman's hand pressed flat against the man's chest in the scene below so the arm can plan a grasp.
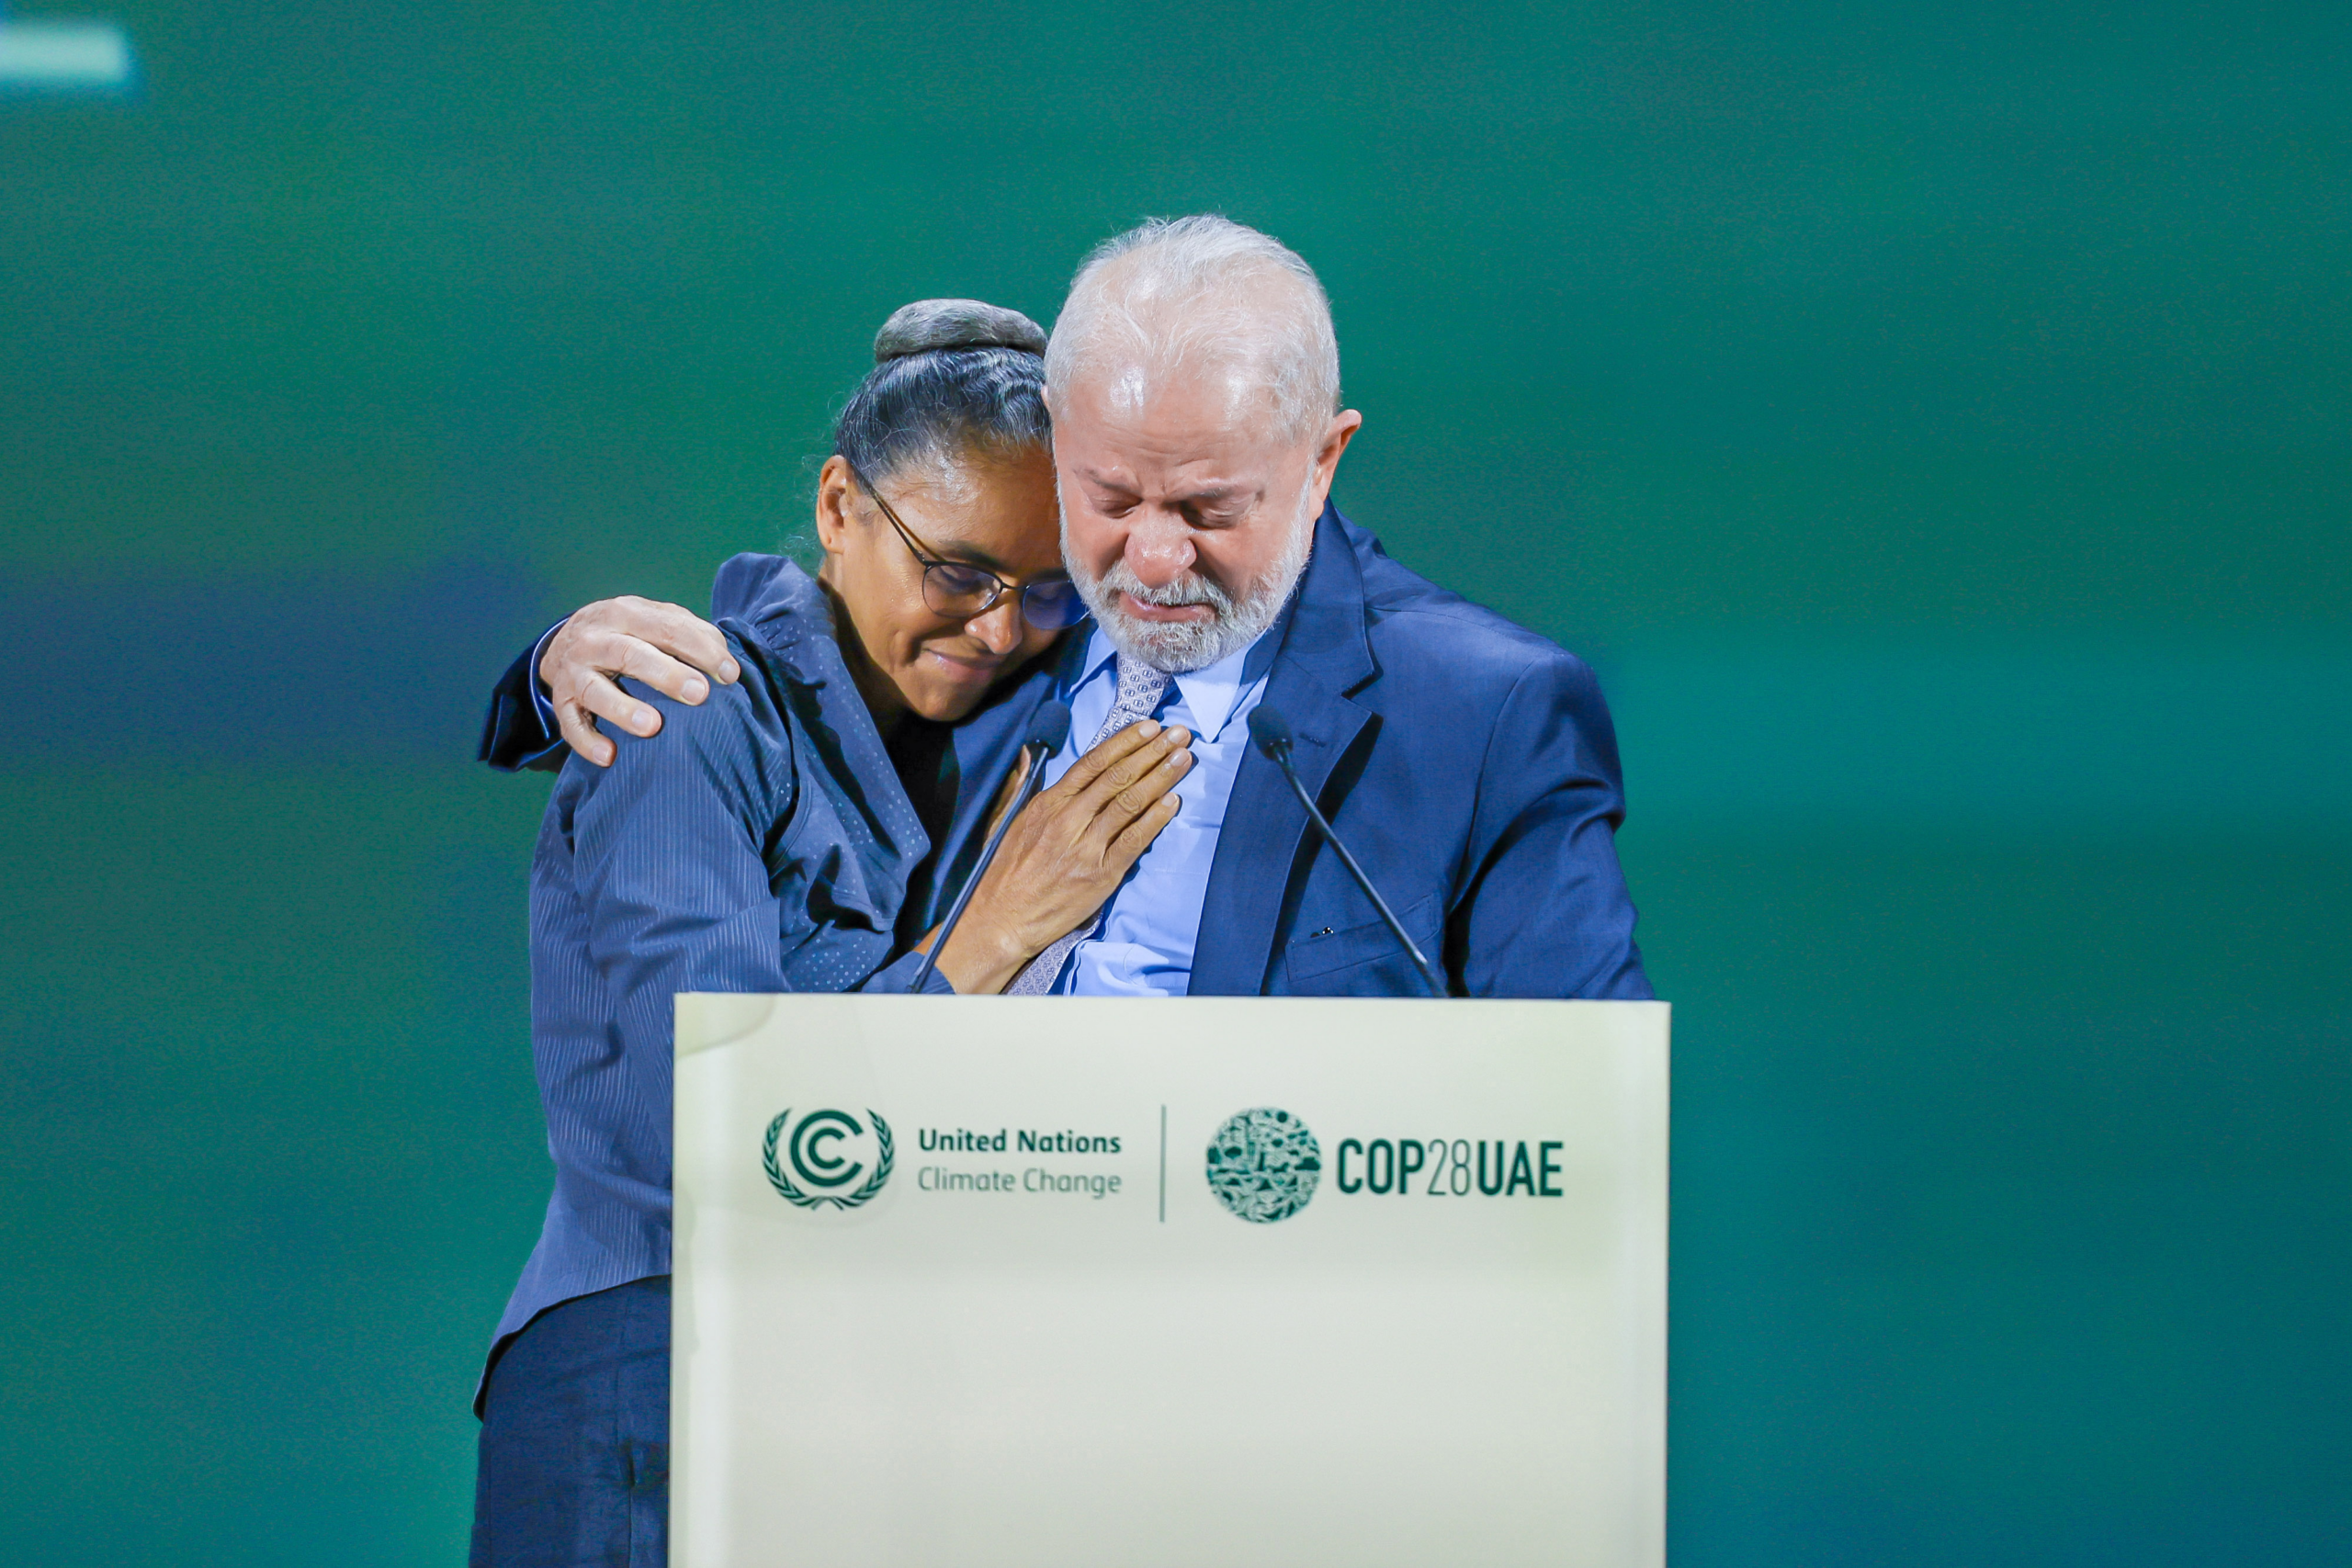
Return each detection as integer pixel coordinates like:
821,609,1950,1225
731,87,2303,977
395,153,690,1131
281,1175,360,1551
938,719,1193,995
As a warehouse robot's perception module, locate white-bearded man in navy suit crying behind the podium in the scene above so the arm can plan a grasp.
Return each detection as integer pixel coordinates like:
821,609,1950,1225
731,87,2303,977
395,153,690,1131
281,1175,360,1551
484,216,1649,997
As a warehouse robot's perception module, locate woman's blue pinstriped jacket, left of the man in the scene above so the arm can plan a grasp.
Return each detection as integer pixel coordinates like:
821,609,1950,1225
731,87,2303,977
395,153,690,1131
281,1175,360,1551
494,559,948,1392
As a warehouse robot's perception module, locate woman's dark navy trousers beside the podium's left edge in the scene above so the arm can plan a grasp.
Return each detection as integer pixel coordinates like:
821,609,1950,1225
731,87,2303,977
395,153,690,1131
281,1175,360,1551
473,1274,671,1568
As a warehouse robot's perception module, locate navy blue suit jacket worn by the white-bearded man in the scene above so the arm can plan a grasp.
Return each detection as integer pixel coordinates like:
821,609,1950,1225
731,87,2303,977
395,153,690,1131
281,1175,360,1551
484,508,1651,999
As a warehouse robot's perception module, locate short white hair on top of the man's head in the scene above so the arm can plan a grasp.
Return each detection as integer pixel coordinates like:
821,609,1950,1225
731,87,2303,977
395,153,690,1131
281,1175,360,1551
1045,214,1339,440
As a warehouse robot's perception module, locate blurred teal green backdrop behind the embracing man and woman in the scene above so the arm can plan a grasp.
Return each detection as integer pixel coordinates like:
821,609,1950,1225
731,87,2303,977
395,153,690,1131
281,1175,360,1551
0,0,2352,1568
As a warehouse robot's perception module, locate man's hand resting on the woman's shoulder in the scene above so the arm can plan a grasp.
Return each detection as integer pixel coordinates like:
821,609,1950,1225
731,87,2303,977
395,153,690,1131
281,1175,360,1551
538,597,741,766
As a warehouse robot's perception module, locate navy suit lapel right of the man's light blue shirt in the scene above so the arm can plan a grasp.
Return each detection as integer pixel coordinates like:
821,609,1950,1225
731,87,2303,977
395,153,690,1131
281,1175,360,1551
1190,505,1378,997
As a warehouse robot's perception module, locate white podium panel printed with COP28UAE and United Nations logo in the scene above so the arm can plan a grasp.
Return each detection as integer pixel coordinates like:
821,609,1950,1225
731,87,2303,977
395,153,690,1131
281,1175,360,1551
671,997,1668,1568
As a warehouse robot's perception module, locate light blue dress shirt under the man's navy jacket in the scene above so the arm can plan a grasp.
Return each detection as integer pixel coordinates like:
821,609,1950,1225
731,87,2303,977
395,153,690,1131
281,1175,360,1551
1045,621,1282,997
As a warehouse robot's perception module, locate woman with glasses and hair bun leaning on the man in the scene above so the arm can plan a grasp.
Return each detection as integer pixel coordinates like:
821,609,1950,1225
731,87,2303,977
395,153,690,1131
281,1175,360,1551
473,301,1190,1565
